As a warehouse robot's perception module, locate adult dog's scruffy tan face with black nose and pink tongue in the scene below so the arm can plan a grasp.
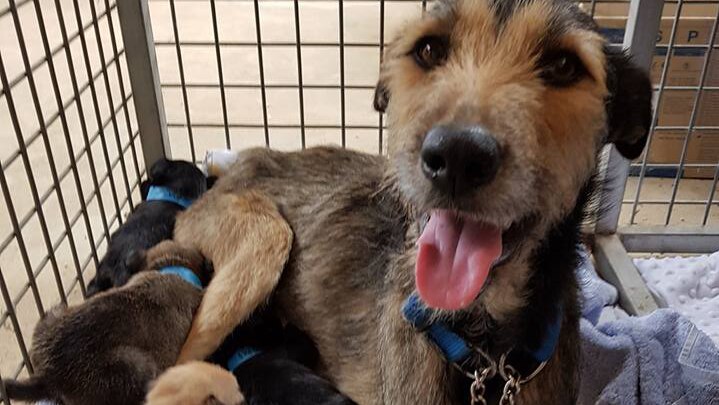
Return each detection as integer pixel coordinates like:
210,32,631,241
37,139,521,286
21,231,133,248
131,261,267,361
375,0,651,309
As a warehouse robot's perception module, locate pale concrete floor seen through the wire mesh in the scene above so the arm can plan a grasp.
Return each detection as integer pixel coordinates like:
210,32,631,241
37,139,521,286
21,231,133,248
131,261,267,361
0,0,719,386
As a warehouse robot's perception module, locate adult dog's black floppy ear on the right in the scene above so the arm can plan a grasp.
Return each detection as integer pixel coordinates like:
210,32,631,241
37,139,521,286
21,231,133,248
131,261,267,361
607,50,652,159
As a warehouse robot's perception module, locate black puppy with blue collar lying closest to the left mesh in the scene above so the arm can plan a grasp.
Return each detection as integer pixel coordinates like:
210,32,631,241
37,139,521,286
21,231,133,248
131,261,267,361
87,159,209,296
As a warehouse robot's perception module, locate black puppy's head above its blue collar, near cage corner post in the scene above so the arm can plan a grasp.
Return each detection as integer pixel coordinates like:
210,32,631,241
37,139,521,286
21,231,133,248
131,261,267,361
140,159,209,200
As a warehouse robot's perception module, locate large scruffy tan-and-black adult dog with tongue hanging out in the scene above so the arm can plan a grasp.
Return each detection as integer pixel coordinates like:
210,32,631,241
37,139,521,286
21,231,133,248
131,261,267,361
162,0,651,405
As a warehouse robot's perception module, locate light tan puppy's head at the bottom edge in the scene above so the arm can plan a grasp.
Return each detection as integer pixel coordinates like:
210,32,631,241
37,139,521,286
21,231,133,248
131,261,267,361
146,361,245,405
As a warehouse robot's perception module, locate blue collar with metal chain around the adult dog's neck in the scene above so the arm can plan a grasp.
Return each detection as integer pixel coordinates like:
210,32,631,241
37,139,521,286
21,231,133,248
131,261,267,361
402,293,562,365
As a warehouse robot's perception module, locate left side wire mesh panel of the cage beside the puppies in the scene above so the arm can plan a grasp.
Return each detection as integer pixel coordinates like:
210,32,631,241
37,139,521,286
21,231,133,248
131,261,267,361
0,0,144,392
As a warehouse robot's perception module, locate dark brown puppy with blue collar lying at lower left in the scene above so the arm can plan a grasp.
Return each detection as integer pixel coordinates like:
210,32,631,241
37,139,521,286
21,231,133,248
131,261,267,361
5,243,209,405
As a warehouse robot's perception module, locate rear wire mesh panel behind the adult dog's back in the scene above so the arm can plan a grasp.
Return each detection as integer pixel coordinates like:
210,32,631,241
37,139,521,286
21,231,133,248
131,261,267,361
149,0,620,161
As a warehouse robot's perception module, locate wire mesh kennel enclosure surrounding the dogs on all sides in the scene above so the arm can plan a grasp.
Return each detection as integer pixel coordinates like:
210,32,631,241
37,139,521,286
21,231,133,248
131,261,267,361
0,0,719,404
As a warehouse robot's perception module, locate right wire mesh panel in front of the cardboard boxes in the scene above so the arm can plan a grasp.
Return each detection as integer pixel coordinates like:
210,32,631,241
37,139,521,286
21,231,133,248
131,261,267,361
622,1,719,226
